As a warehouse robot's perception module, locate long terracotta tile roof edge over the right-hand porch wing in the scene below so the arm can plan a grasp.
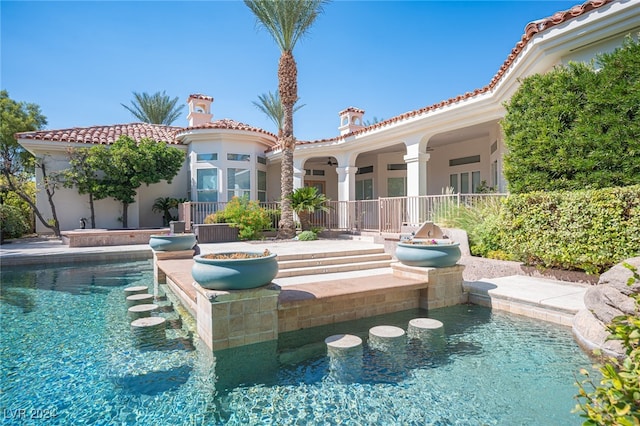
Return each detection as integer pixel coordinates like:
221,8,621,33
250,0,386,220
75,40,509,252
296,0,616,145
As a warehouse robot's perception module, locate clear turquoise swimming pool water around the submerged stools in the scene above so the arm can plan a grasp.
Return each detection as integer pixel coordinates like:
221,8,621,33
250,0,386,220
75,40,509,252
0,261,591,425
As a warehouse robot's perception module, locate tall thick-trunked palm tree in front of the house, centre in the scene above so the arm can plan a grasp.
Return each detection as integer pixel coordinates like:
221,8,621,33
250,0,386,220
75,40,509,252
244,0,327,238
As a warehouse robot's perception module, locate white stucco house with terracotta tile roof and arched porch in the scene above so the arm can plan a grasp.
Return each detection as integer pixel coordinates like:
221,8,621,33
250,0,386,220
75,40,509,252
17,0,640,232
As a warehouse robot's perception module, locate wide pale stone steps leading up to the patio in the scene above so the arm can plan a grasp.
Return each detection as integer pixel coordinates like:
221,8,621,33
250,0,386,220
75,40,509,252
276,247,393,279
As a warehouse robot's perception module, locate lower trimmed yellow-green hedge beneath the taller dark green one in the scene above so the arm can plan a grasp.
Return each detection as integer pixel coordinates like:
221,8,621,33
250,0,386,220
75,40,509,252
499,185,640,273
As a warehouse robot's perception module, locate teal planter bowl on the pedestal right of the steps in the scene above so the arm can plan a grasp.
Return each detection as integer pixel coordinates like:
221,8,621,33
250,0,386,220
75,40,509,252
396,240,461,268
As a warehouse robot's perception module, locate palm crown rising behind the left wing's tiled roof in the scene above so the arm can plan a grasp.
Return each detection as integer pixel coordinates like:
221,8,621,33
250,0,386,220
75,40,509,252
120,91,184,126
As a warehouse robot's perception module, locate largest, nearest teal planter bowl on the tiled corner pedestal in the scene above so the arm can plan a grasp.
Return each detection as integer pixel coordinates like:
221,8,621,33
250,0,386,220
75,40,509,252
191,252,278,290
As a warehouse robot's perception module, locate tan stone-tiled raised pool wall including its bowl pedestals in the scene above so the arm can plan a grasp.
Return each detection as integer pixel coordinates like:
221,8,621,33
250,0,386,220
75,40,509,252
155,253,466,351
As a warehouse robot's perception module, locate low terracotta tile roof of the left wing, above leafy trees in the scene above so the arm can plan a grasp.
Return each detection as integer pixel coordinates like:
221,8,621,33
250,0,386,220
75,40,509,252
16,123,182,145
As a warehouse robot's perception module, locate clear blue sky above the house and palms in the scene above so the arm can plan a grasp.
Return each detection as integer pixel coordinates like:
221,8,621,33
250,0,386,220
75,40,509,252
0,0,580,140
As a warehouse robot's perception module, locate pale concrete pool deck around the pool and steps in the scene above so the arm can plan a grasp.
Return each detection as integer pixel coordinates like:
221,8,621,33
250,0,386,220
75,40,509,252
0,238,588,327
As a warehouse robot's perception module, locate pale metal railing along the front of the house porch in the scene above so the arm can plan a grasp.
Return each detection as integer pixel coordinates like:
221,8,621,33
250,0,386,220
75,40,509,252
179,194,506,233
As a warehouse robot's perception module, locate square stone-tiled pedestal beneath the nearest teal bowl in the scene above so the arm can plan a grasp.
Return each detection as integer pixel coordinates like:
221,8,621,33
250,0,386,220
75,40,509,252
193,282,280,351
